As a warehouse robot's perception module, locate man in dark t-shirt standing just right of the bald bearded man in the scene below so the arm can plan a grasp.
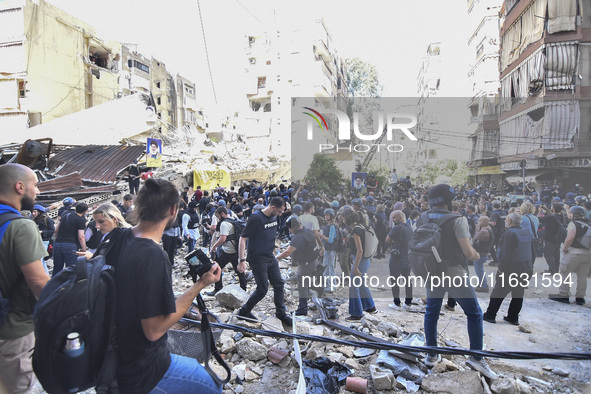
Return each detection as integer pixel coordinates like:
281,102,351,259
52,202,88,276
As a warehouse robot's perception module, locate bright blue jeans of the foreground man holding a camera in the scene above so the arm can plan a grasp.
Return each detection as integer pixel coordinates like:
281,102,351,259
150,354,222,394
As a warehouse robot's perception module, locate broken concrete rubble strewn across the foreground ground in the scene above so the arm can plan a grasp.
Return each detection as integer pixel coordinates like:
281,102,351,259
165,243,581,394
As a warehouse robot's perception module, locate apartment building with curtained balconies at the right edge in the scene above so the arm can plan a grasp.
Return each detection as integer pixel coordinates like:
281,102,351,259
498,0,591,190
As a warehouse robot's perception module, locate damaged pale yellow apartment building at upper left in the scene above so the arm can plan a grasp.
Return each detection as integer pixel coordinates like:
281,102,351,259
0,0,121,143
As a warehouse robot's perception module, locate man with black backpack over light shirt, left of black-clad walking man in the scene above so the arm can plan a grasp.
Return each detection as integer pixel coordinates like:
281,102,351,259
206,207,246,296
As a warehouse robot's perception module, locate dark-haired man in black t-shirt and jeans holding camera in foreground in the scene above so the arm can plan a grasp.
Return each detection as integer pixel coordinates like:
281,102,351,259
115,178,222,393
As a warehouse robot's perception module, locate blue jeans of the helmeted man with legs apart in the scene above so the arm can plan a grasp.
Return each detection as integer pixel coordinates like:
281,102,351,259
425,267,484,359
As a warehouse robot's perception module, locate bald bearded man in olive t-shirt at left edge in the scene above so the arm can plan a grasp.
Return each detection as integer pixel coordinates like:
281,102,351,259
0,164,49,393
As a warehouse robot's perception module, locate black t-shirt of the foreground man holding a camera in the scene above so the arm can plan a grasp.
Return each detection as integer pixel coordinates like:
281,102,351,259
115,234,176,393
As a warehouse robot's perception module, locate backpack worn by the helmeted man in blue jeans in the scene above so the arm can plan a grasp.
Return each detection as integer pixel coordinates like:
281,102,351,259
408,212,460,280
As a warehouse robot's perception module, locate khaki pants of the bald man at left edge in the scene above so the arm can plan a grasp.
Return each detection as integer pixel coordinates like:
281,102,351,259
0,332,37,394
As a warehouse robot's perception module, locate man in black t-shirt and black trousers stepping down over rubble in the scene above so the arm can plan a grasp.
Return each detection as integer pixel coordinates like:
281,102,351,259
238,197,293,330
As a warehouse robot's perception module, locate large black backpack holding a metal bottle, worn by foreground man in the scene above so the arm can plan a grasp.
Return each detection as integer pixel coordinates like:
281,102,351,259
33,229,131,393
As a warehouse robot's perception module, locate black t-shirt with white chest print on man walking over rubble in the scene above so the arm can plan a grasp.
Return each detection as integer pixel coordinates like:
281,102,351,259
241,211,278,264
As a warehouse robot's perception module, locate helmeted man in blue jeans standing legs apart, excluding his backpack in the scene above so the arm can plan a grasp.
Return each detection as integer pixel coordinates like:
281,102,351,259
415,184,497,379
